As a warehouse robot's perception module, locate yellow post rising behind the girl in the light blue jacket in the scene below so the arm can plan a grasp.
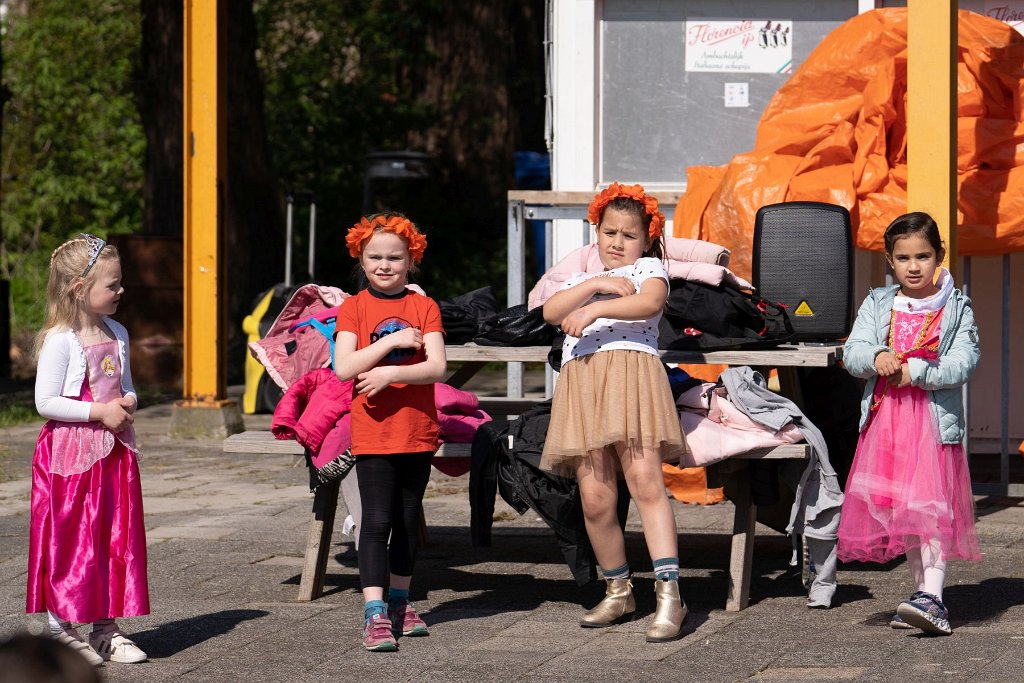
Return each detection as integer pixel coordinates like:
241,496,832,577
906,0,957,278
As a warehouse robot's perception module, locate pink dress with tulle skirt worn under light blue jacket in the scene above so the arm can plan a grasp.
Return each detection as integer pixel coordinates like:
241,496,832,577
838,304,981,562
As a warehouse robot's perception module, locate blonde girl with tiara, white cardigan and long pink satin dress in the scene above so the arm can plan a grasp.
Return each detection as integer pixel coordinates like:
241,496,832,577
26,234,150,665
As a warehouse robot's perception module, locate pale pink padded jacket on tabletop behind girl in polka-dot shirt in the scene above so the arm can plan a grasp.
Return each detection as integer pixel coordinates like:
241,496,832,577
526,237,753,308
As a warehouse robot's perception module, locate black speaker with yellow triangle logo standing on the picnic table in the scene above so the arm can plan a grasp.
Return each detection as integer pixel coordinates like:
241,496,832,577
753,202,853,341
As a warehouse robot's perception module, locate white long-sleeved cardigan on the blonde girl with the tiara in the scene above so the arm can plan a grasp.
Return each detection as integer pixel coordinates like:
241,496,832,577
36,316,138,422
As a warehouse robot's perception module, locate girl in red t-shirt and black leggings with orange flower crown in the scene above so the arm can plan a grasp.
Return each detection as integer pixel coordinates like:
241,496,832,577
334,213,446,652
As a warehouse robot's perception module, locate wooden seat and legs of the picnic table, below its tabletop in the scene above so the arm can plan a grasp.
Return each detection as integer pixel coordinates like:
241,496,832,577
223,430,809,611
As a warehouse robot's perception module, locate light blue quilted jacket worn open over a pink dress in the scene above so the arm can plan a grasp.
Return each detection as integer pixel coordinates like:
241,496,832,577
843,285,981,443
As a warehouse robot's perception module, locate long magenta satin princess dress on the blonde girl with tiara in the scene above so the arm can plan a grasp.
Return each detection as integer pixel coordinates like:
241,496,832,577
26,341,150,623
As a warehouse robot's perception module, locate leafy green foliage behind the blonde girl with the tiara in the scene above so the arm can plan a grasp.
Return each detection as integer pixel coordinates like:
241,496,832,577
0,0,145,332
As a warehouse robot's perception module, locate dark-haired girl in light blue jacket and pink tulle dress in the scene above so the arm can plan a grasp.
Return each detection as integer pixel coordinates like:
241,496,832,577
839,212,981,635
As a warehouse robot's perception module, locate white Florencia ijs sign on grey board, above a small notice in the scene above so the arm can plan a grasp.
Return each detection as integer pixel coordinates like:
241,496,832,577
683,19,794,74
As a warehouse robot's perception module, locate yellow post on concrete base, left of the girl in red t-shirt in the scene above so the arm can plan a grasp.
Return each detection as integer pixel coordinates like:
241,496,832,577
183,0,227,403
